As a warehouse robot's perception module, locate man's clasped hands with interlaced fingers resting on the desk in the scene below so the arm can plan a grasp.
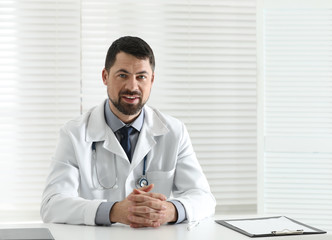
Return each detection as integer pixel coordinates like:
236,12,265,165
110,184,177,228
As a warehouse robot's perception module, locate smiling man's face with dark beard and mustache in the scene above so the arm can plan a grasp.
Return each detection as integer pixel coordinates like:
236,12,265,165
102,52,154,123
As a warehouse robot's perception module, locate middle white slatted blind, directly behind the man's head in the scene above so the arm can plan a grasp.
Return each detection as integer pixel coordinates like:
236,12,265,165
82,0,257,213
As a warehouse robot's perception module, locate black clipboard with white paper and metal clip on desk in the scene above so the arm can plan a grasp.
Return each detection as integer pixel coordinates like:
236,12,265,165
215,216,326,237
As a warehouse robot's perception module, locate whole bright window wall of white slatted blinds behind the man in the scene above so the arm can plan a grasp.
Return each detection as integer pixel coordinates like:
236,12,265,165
5,0,332,230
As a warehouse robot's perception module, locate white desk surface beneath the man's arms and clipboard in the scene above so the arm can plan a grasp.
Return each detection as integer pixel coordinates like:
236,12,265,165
0,218,332,240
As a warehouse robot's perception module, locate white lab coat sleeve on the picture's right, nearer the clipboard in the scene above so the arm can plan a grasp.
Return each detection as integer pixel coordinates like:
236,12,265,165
173,124,216,222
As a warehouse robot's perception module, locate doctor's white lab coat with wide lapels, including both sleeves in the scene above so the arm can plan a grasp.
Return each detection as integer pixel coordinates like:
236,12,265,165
41,99,216,225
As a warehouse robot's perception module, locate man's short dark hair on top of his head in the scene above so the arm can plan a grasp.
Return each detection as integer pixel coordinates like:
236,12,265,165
105,36,155,72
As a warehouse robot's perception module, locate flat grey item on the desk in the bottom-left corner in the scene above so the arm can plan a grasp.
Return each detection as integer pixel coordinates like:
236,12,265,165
0,228,54,240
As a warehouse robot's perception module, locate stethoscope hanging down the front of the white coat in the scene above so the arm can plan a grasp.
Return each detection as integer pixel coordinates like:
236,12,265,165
91,142,149,189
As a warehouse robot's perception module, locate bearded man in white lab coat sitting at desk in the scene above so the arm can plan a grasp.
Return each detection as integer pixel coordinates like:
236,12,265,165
41,37,215,228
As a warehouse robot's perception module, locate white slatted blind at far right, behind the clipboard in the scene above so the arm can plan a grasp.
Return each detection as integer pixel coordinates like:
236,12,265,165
263,9,332,230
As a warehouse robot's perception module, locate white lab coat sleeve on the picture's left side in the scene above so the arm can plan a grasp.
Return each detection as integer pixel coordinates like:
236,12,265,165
40,128,103,225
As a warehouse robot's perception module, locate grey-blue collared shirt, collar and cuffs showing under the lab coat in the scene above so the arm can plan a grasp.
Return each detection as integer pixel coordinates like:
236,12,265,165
95,100,186,226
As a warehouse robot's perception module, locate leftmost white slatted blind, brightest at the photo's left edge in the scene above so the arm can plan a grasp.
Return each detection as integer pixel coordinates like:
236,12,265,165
0,0,80,221
